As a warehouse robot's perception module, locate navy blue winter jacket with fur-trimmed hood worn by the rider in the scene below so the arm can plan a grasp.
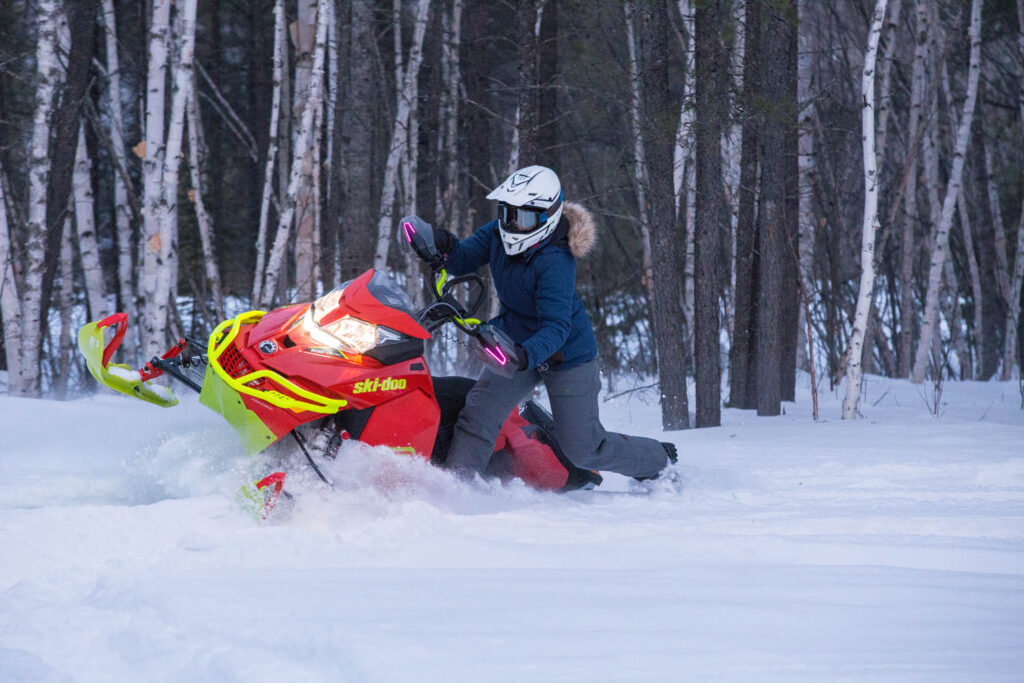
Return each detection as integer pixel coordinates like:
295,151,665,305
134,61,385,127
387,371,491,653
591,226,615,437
444,203,597,370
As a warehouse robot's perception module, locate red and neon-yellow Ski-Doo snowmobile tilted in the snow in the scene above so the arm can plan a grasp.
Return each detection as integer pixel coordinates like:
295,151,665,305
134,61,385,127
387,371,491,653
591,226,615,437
78,216,601,517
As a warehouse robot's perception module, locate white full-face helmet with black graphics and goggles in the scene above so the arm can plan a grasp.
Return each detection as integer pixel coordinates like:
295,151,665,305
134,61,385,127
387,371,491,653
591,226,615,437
487,166,562,256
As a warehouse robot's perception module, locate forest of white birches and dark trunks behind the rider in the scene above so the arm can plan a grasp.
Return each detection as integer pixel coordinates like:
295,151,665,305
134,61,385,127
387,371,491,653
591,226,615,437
0,0,1024,428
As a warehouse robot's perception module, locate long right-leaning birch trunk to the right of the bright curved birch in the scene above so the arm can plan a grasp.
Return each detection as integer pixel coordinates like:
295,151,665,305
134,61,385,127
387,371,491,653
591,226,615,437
912,0,981,384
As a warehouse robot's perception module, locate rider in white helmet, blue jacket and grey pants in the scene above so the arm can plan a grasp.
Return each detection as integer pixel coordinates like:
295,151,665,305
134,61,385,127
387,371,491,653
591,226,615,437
419,166,676,479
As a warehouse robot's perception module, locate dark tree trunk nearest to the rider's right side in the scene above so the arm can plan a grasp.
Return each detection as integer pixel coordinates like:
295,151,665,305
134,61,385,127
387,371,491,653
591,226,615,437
639,0,689,429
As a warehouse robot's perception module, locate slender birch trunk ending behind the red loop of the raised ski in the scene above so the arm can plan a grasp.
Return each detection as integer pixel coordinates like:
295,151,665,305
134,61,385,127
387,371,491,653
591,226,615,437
103,0,135,357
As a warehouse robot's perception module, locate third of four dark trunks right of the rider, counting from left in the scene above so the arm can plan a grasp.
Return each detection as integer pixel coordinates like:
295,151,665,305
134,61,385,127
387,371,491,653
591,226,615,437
729,0,761,409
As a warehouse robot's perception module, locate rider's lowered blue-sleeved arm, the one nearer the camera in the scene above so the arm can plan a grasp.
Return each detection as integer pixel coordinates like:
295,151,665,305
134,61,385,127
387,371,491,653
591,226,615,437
522,251,575,368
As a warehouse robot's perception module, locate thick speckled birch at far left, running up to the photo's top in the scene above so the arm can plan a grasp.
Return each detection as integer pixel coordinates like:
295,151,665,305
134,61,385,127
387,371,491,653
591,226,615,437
18,0,61,397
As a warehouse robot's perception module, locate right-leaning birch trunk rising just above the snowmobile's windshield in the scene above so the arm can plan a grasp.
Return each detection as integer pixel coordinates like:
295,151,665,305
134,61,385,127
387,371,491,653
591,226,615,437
374,0,430,270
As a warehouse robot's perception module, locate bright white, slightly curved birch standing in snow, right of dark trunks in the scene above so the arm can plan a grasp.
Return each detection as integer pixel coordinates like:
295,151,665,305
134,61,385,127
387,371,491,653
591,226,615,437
843,0,888,420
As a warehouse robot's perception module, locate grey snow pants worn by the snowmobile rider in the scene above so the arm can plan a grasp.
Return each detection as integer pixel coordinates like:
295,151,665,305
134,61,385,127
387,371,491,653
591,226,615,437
447,360,668,477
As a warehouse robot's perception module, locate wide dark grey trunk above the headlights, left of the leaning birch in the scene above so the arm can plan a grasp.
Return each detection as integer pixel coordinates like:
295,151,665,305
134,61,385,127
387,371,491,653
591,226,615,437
342,0,379,281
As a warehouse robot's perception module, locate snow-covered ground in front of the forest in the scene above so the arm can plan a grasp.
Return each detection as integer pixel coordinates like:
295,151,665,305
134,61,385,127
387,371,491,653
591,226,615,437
0,378,1024,683
